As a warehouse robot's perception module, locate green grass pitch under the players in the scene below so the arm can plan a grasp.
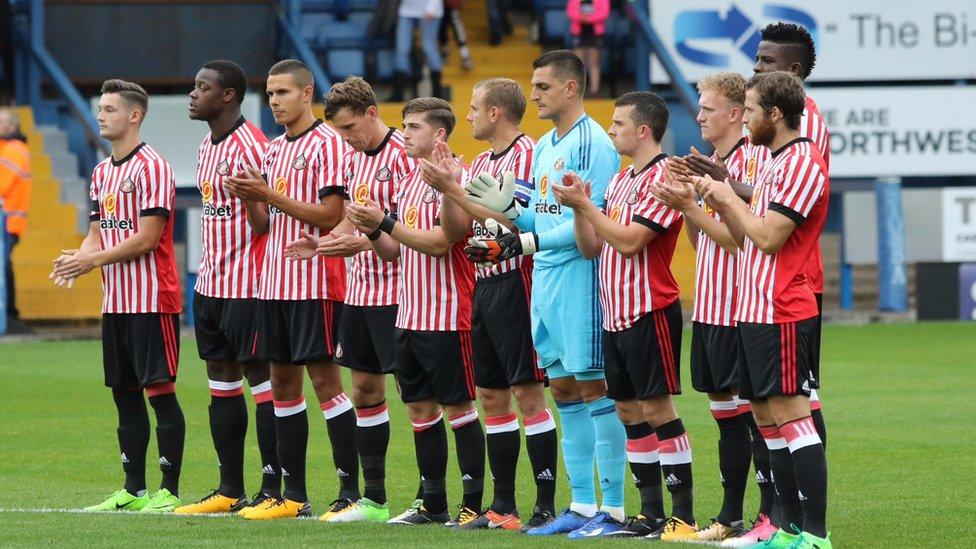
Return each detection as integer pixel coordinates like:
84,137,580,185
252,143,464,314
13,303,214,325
0,323,976,547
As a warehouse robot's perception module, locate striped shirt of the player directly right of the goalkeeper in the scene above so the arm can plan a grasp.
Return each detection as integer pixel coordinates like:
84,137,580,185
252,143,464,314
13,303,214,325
600,154,682,332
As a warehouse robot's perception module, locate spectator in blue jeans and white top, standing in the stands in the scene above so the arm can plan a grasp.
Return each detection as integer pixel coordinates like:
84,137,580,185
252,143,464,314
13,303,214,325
390,0,444,102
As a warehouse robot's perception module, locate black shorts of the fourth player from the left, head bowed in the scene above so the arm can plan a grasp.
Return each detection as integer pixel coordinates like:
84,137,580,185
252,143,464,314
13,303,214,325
335,305,397,374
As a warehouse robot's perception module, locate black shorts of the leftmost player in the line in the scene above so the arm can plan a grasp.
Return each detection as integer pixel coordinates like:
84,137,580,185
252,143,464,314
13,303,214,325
102,313,180,389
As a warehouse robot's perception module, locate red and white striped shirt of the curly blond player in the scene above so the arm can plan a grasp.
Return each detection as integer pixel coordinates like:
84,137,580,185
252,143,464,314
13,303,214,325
691,137,769,326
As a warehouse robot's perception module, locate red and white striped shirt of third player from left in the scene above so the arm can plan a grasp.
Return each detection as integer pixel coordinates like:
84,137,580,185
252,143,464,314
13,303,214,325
258,120,348,301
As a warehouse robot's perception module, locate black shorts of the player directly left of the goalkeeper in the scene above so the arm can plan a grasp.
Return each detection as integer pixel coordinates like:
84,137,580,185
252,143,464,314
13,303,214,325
471,270,546,389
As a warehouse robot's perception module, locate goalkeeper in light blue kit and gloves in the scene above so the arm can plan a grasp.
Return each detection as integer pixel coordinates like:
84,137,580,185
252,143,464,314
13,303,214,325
465,50,626,538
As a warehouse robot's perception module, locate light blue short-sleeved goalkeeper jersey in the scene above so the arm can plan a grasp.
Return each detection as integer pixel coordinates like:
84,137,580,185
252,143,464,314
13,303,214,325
515,114,620,269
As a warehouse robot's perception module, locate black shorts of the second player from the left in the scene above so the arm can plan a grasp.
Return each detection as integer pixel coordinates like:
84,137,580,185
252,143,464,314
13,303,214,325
193,292,258,362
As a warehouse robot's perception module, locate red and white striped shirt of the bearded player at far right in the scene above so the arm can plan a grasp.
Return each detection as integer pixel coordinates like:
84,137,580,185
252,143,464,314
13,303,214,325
736,138,830,324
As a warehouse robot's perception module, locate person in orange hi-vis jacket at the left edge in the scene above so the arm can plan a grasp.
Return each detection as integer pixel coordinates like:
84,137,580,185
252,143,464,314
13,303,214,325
0,109,31,331
